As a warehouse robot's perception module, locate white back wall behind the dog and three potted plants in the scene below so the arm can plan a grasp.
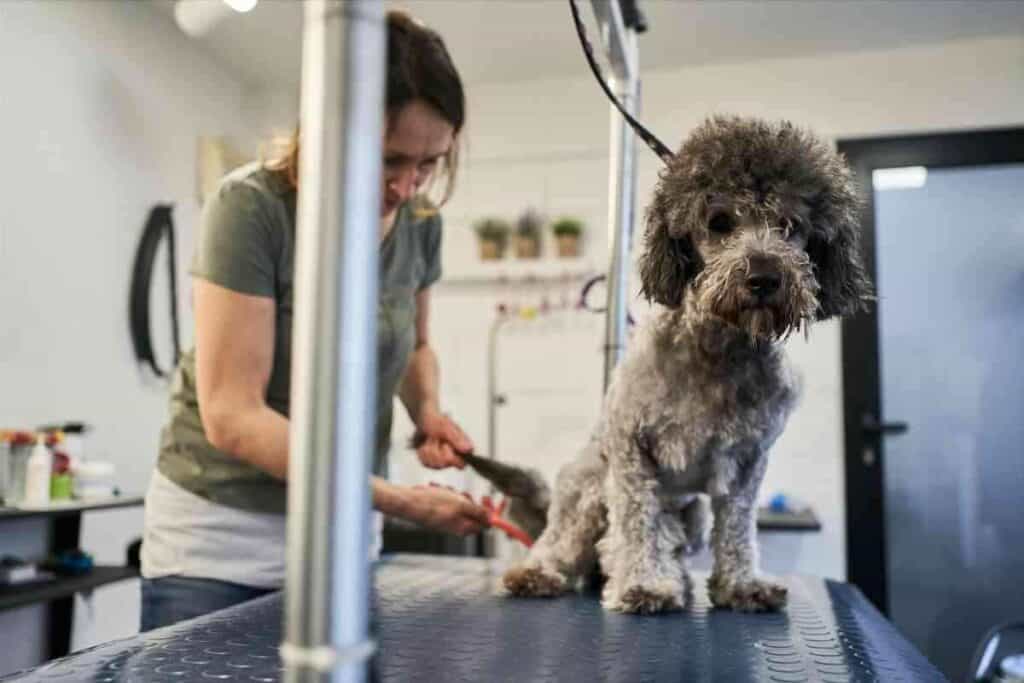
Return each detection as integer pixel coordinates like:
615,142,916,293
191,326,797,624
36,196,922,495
385,38,1024,579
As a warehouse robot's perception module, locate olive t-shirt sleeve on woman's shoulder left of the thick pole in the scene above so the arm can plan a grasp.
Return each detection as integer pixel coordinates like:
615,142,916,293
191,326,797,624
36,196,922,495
190,182,280,298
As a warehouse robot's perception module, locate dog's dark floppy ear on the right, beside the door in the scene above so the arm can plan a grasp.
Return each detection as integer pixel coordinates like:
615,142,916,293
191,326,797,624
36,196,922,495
807,160,871,321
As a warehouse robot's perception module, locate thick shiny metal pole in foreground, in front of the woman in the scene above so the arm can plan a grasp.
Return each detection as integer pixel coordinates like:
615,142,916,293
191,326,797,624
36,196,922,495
281,0,386,683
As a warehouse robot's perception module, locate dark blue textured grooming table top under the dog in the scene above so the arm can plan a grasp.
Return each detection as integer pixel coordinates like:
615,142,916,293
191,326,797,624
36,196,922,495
4,555,945,683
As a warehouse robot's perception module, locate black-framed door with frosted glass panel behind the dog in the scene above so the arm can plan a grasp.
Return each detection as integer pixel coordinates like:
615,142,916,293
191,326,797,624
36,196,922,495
839,129,1024,681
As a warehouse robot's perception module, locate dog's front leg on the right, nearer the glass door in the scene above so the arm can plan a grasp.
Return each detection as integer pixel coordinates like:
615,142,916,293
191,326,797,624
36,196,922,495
708,453,786,611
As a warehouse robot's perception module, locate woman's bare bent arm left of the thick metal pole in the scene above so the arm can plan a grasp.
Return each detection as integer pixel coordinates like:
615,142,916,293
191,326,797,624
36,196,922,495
194,278,288,479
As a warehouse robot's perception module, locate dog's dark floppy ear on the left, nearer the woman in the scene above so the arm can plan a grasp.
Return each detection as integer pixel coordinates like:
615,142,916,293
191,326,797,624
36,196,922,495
640,198,701,308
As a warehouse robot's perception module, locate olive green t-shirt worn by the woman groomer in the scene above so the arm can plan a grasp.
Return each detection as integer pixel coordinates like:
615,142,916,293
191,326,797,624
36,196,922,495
157,164,441,513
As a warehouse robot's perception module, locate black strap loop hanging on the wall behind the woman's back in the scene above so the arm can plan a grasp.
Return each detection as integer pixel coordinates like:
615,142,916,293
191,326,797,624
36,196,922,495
128,204,181,377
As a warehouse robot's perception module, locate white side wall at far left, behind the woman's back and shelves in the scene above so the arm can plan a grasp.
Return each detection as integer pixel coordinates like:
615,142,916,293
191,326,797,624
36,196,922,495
0,0,251,674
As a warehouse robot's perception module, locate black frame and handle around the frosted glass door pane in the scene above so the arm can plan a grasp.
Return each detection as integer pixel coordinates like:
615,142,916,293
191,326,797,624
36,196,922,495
837,128,1024,615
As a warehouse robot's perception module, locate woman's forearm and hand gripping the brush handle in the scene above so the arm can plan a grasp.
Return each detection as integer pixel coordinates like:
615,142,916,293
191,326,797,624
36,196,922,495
398,289,473,469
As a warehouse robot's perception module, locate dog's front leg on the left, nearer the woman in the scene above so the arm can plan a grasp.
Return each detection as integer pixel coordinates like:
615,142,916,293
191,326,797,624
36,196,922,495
598,437,686,613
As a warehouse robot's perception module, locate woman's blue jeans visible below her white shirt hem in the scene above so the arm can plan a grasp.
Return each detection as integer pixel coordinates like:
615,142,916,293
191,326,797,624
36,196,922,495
139,577,273,631
